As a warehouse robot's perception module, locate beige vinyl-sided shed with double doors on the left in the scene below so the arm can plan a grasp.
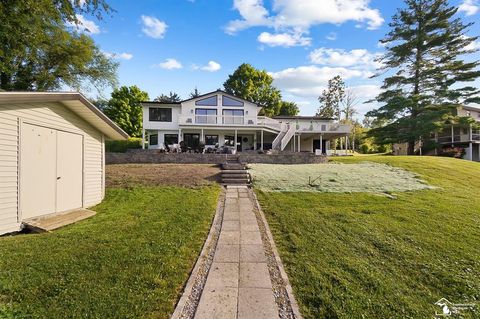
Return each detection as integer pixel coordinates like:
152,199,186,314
0,92,128,234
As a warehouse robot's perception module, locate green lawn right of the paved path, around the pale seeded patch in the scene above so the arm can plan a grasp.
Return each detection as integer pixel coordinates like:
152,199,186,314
257,156,480,318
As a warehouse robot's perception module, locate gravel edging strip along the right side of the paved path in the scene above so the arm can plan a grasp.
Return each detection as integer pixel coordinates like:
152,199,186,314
249,189,303,319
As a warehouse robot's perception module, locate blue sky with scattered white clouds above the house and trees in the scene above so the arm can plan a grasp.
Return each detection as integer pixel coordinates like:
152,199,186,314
71,0,480,116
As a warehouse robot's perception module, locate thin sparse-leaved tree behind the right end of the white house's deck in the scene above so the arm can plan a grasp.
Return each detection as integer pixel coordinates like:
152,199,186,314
317,75,345,120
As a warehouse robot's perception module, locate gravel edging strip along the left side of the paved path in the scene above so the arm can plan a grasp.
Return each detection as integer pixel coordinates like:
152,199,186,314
171,187,226,319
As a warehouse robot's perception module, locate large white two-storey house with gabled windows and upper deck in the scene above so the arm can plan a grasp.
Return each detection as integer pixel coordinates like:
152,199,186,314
142,90,351,154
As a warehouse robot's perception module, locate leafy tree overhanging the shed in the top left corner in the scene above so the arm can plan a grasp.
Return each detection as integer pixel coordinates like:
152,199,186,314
0,0,118,91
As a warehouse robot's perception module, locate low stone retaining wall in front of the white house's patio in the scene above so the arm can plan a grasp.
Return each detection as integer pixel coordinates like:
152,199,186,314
105,150,328,164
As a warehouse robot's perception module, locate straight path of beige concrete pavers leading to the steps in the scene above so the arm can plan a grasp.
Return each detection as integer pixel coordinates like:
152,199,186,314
195,186,278,319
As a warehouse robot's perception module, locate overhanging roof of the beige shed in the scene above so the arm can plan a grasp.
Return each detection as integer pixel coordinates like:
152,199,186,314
0,92,128,140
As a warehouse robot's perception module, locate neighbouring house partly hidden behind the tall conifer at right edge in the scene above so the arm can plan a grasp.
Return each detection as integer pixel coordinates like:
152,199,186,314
435,105,480,162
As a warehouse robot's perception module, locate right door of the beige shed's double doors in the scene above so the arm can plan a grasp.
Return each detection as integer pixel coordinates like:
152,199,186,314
56,131,83,212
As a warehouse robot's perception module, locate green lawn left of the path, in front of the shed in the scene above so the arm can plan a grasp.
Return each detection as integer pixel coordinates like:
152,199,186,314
0,187,219,319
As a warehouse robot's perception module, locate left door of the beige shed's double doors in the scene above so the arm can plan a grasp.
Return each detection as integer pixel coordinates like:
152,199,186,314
20,124,57,219
